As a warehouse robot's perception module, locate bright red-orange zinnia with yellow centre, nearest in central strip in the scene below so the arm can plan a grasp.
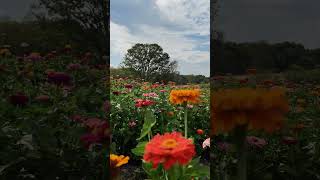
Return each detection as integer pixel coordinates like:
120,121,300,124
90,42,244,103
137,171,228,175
143,132,196,170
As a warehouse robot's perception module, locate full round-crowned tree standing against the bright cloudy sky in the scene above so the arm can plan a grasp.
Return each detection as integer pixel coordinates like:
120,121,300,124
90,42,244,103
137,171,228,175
123,43,177,81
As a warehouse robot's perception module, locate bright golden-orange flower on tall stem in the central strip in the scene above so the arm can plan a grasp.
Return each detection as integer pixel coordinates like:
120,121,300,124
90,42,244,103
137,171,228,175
169,89,200,104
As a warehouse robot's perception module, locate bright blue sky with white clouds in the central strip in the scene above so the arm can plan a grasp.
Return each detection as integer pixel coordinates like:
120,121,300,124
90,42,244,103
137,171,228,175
110,0,210,76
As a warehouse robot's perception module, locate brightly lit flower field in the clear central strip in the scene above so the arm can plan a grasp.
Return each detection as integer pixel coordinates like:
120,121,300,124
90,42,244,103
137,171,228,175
110,77,210,180
